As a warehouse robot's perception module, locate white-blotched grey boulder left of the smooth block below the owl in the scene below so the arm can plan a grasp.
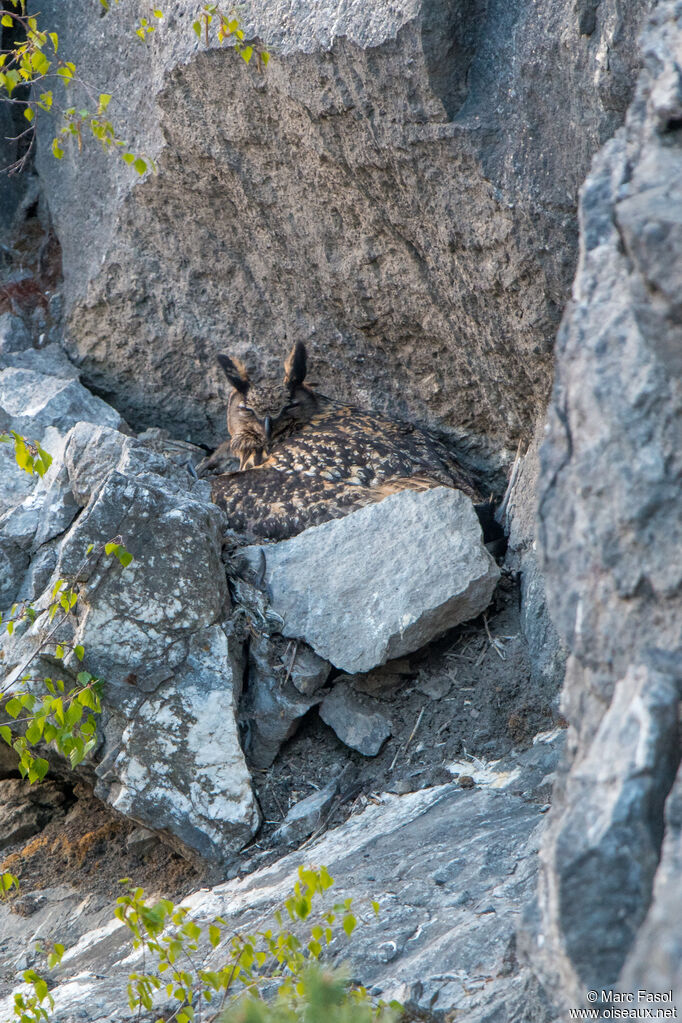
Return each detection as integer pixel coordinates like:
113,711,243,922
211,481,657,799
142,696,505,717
1,423,260,864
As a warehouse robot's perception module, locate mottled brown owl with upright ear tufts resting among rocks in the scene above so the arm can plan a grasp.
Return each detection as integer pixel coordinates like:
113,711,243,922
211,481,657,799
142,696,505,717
208,342,490,539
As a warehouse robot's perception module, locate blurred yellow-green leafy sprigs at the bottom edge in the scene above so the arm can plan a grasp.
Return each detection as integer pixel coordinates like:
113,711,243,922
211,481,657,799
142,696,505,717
5,866,396,1023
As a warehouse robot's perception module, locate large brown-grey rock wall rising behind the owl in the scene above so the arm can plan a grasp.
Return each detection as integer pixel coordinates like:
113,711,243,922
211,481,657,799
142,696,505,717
38,0,652,452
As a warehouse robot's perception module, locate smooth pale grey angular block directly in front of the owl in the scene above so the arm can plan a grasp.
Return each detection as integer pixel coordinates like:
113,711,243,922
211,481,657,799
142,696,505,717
242,487,500,673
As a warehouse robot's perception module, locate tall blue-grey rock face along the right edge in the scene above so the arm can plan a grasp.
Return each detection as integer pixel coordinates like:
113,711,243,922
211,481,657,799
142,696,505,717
540,3,682,1005
